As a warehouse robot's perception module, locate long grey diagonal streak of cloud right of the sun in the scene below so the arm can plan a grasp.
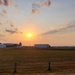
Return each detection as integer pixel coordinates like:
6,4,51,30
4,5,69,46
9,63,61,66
41,22,75,35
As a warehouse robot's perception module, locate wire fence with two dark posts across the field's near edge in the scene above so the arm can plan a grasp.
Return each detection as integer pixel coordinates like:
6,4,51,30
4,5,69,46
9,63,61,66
0,62,75,73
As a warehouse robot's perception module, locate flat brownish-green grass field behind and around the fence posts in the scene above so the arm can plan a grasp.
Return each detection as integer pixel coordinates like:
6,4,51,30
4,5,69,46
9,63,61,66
0,48,75,75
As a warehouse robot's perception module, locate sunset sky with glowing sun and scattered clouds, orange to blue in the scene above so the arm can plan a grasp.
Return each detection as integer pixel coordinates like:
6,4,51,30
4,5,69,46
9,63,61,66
0,0,75,46
